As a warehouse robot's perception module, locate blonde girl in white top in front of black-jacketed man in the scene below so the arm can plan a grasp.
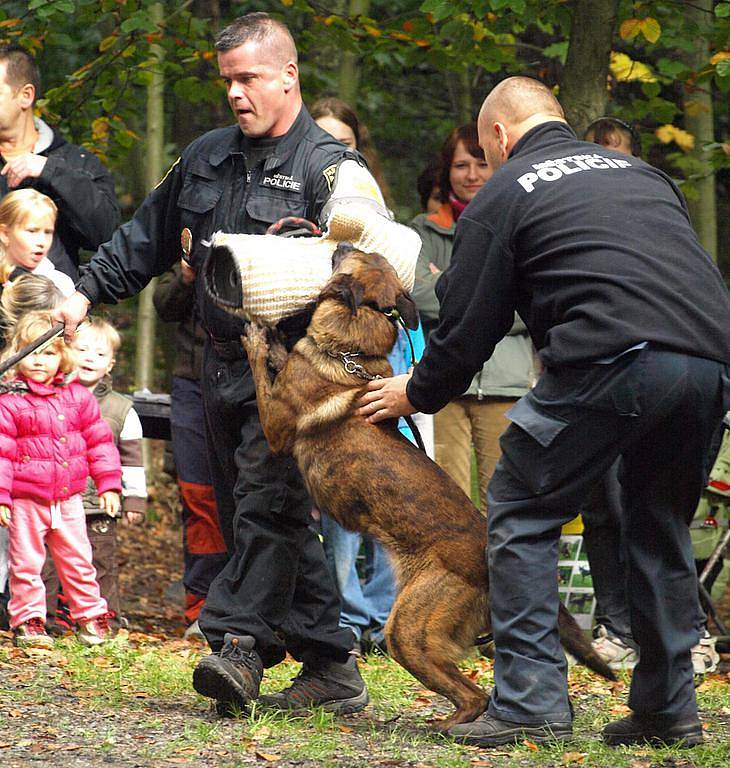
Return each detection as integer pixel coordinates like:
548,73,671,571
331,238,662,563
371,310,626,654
0,189,74,296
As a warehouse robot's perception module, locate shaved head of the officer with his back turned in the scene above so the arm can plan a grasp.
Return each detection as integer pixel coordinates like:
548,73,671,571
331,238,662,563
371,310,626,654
477,77,565,171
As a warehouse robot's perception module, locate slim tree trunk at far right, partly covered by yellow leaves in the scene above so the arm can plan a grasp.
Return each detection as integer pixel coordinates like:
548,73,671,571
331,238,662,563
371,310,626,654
684,0,717,261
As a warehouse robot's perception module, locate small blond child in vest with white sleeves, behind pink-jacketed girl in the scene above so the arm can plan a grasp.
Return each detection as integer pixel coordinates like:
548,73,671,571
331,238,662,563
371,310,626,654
43,316,147,629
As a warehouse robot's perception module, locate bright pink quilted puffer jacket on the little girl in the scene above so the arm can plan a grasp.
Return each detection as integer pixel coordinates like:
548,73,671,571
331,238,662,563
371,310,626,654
0,374,122,506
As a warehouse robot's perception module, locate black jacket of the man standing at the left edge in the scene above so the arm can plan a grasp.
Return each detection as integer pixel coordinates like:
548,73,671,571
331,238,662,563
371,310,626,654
0,120,119,280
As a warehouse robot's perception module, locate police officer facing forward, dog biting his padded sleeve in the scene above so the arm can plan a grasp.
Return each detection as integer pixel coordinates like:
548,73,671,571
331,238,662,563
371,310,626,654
58,13,383,714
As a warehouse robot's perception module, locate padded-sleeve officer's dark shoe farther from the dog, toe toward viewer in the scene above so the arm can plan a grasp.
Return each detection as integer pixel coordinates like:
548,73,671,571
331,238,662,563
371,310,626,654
193,632,264,716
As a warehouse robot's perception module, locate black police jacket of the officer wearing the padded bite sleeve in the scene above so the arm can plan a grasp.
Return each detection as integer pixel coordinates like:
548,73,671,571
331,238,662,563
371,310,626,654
78,107,355,340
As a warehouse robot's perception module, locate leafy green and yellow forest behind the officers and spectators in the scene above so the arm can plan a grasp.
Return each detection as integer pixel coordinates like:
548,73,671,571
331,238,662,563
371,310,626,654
0,0,730,391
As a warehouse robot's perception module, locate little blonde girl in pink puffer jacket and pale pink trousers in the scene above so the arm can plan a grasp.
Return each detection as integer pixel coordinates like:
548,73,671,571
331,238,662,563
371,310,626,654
0,312,121,648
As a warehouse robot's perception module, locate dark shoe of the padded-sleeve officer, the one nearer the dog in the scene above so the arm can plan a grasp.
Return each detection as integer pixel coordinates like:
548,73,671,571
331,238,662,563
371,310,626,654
258,655,369,715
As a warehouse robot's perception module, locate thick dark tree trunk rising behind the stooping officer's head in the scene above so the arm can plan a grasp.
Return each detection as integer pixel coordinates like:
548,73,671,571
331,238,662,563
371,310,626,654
560,0,618,138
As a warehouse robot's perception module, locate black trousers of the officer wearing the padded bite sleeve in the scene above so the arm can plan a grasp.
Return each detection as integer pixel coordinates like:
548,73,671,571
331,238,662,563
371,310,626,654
199,343,354,667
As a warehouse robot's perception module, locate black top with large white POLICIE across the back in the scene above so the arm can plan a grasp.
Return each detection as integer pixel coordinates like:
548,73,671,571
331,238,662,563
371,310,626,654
408,121,730,413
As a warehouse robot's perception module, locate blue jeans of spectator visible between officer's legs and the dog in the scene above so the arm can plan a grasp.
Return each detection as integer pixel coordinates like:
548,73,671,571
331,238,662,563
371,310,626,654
321,512,396,643
